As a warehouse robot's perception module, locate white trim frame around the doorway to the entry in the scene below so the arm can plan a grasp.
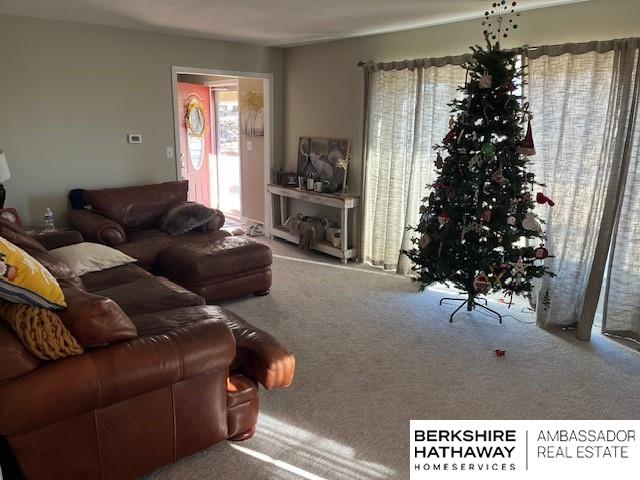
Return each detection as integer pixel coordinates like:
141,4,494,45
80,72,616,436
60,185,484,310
171,65,275,228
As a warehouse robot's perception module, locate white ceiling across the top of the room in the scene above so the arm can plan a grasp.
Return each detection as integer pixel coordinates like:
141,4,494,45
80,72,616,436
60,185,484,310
0,0,587,46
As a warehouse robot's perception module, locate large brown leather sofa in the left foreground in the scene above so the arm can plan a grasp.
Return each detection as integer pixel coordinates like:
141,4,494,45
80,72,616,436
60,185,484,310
0,219,295,480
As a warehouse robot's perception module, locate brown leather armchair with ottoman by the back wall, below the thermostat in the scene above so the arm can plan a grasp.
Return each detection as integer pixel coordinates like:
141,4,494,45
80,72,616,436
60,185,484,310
69,181,271,303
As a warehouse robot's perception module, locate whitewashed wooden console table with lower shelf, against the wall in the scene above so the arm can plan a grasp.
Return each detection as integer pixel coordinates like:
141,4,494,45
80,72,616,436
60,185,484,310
267,184,360,263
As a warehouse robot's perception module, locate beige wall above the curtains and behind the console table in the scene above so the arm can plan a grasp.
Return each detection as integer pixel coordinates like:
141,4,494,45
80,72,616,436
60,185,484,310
285,0,640,197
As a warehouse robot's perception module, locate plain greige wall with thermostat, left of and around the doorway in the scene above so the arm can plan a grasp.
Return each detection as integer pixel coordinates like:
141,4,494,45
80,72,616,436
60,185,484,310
0,16,283,224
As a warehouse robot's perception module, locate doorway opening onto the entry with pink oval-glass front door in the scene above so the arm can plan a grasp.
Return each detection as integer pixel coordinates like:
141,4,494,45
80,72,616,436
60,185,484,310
172,67,273,225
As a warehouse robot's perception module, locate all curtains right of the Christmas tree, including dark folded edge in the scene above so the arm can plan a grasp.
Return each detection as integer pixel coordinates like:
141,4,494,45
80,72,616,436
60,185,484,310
527,39,640,340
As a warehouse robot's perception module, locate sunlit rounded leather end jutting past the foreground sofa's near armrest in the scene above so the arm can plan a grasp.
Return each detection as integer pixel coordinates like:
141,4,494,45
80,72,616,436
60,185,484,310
225,311,296,390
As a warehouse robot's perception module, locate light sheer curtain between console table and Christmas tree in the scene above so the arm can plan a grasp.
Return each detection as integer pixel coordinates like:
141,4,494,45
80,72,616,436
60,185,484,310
362,61,466,273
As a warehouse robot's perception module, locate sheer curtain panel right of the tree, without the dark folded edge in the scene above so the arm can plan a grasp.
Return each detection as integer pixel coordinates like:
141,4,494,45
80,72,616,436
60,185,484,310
525,47,614,326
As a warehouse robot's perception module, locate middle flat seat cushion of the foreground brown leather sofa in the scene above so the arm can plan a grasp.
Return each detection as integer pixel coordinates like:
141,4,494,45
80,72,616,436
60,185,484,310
96,277,205,315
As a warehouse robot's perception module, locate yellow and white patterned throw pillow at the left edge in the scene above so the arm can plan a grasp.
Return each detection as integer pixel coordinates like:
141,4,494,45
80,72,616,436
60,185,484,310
0,237,67,310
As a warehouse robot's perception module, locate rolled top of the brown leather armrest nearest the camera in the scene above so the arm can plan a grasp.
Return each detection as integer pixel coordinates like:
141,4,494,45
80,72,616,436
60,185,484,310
0,322,235,435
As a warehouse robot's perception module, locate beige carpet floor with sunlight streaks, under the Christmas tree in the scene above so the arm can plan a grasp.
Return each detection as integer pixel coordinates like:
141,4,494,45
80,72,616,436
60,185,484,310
149,240,640,480
